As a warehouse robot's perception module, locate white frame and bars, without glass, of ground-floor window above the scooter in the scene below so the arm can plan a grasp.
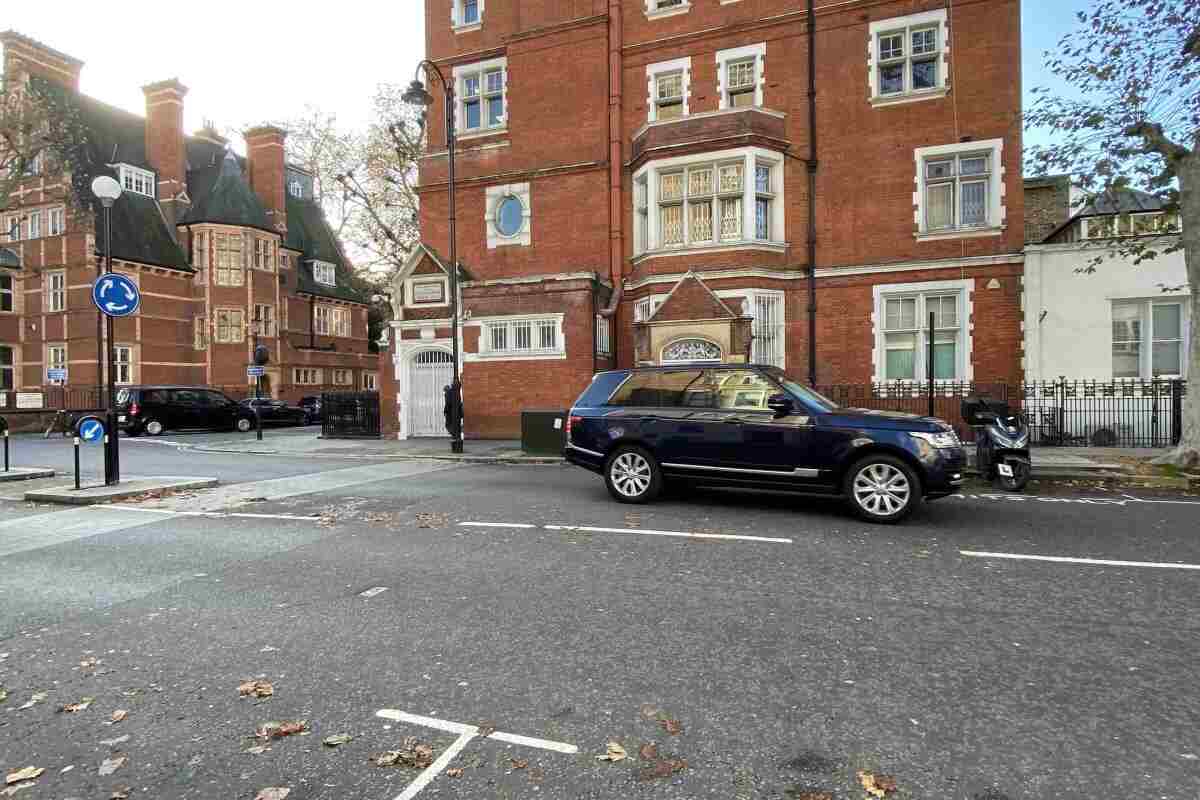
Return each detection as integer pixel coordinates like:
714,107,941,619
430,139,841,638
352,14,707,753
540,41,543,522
871,278,974,386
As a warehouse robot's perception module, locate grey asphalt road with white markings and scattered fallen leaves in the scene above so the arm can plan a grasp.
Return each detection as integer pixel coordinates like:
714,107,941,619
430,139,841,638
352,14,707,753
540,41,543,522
0,447,1200,800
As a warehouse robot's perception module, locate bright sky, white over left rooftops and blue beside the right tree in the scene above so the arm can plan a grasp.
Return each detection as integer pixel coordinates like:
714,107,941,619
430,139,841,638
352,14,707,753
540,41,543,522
0,0,1088,149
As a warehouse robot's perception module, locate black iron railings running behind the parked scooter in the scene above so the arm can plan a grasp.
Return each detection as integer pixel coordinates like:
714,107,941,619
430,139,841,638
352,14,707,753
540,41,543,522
818,378,1187,447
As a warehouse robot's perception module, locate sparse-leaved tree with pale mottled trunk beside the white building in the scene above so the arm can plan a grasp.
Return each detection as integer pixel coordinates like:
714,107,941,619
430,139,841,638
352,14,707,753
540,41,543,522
1026,0,1200,467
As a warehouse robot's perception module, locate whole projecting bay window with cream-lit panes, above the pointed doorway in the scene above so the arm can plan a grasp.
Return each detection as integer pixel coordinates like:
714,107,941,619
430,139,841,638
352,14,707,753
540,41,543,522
634,148,784,255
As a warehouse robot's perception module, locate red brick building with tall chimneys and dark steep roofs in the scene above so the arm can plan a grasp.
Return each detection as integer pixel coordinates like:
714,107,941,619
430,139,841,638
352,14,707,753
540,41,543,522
0,31,378,407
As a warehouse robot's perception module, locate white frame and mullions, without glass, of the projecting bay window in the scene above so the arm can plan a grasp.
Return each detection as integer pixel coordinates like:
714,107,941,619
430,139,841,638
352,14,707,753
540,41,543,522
632,148,787,258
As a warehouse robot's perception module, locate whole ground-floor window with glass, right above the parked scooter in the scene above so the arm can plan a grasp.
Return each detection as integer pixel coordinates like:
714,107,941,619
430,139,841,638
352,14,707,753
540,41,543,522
875,279,973,383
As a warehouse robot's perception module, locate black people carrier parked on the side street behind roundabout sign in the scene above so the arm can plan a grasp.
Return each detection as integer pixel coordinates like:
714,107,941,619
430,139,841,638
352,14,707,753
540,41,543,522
116,386,254,437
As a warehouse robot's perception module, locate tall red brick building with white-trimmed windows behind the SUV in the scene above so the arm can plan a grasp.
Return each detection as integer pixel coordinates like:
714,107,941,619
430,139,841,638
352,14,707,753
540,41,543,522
390,0,1024,437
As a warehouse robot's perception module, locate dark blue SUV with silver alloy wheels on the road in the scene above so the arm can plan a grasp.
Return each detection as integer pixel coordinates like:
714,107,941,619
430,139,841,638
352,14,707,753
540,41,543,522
564,365,966,523
